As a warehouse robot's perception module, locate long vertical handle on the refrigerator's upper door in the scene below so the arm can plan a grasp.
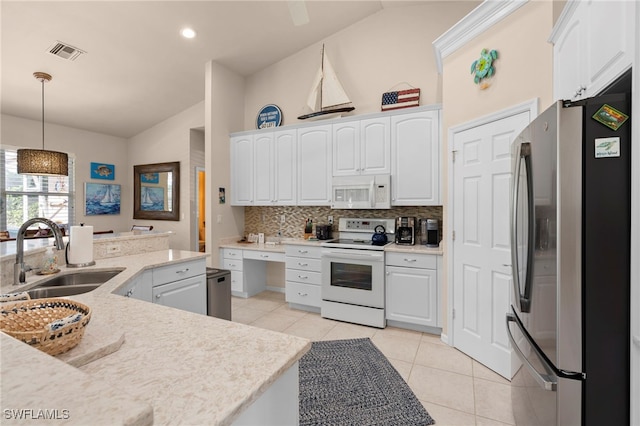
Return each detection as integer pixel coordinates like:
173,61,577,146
511,142,535,313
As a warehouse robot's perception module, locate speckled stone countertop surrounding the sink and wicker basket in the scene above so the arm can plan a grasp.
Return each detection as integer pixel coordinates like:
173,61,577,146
1,250,311,425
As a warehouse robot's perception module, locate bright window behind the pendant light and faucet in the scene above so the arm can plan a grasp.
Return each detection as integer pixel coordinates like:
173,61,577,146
0,147,75,237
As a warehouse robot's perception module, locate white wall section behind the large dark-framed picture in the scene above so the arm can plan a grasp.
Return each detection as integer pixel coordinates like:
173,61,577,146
125,101,204,250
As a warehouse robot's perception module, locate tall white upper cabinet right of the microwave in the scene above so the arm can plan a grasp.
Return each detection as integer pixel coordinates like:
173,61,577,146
391,110,441,206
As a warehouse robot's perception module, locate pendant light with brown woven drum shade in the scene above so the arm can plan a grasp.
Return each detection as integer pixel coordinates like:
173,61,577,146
18,72,69,176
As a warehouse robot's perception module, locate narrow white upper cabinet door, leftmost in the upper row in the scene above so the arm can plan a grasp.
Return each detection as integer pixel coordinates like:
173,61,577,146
230,135,254,206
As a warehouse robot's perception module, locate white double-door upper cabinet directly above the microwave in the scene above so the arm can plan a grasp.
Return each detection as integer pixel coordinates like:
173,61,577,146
332,116,391,176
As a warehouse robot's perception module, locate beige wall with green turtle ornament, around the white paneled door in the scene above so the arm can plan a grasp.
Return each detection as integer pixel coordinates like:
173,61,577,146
442,1,554,333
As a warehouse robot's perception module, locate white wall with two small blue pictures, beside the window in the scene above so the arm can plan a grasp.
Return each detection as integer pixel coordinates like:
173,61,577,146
1,114,133,232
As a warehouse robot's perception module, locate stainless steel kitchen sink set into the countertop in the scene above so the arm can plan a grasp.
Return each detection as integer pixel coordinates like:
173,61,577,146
27,269,124,299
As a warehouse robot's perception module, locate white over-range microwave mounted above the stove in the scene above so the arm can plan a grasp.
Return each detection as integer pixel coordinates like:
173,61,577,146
331,175,391,209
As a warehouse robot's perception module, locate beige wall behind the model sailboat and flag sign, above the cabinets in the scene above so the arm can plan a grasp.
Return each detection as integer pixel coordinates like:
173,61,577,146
242,1,480,131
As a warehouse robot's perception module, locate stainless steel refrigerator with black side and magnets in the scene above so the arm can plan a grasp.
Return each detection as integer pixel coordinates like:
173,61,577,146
506,93,639,426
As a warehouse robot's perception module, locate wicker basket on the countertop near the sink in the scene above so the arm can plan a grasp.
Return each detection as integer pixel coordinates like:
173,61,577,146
0,298,91,355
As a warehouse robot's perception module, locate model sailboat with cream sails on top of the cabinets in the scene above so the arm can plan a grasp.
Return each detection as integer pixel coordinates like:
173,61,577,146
298,45,355,120
